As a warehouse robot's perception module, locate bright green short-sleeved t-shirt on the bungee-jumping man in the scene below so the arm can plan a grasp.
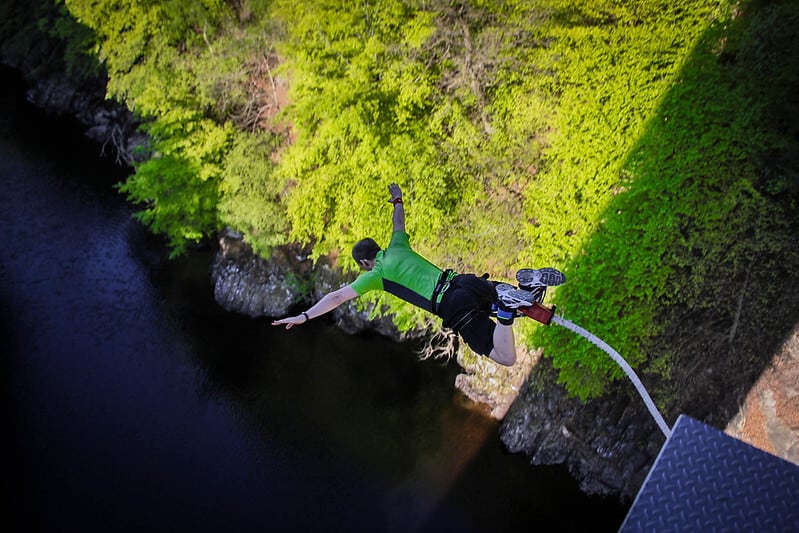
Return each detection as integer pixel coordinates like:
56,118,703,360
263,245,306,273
350,231,441,311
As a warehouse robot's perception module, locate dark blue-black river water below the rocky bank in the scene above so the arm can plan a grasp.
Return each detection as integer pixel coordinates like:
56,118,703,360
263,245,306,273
0,67,626,531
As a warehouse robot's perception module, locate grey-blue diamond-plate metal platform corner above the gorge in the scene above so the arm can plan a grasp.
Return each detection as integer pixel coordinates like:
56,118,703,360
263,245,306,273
620,415,799,533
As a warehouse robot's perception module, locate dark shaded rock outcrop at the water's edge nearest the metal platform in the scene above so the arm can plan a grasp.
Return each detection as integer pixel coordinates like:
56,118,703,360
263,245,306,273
500,358,665,500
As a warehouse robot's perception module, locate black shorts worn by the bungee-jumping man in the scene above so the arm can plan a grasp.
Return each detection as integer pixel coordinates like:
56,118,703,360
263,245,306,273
438,274,497,356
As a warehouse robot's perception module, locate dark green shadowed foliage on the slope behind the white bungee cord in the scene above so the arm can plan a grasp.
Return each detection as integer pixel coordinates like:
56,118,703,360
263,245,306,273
560,1,799,427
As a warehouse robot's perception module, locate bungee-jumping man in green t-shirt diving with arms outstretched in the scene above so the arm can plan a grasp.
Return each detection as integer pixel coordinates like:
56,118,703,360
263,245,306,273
272,183,566,366
